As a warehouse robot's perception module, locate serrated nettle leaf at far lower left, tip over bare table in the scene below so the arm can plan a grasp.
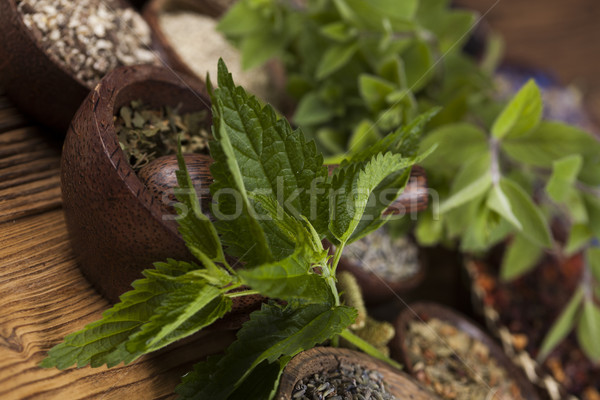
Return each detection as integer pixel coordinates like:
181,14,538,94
41,260,209,369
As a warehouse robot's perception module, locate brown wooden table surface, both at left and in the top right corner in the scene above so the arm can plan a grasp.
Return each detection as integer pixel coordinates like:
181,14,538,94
0,0,600,400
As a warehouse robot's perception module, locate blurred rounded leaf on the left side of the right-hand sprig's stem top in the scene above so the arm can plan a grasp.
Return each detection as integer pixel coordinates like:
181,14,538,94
421,123,488,178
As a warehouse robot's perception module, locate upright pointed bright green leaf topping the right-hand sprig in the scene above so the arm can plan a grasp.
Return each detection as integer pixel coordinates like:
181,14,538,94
492,79,544,139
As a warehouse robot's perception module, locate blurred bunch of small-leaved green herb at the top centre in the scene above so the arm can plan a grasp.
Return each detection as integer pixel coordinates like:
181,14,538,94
219,0,498,162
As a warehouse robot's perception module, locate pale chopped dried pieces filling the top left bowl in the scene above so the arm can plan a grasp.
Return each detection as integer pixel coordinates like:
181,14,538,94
17,0,156,88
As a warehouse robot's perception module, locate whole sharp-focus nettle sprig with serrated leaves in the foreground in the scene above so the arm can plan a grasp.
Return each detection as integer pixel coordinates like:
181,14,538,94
42,61,430,400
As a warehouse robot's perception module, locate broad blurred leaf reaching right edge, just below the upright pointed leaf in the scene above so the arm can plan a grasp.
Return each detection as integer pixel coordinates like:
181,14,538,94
501,121,600,185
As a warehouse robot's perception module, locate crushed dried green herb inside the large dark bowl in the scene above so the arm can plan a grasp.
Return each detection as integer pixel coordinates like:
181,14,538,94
114,101,211,171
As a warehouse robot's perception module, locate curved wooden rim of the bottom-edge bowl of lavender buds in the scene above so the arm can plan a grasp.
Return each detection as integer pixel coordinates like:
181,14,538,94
276,347,439,400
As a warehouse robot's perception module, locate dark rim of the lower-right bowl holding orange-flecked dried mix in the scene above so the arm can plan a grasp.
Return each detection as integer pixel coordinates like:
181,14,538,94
390,303,539,400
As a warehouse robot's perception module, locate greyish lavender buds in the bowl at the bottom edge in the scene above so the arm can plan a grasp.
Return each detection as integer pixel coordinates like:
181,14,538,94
292,363,395,400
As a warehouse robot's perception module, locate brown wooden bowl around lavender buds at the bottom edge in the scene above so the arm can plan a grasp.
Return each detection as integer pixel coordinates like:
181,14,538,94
275,347,439,400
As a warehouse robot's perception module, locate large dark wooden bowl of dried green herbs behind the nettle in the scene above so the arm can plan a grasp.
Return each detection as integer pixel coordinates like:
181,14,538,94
61,65,262,325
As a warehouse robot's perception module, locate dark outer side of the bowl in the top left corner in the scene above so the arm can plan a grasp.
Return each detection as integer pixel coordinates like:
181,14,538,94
0,0,91,135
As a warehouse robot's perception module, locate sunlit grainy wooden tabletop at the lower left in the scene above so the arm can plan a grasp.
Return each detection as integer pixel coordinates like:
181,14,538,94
0,96,234,400
